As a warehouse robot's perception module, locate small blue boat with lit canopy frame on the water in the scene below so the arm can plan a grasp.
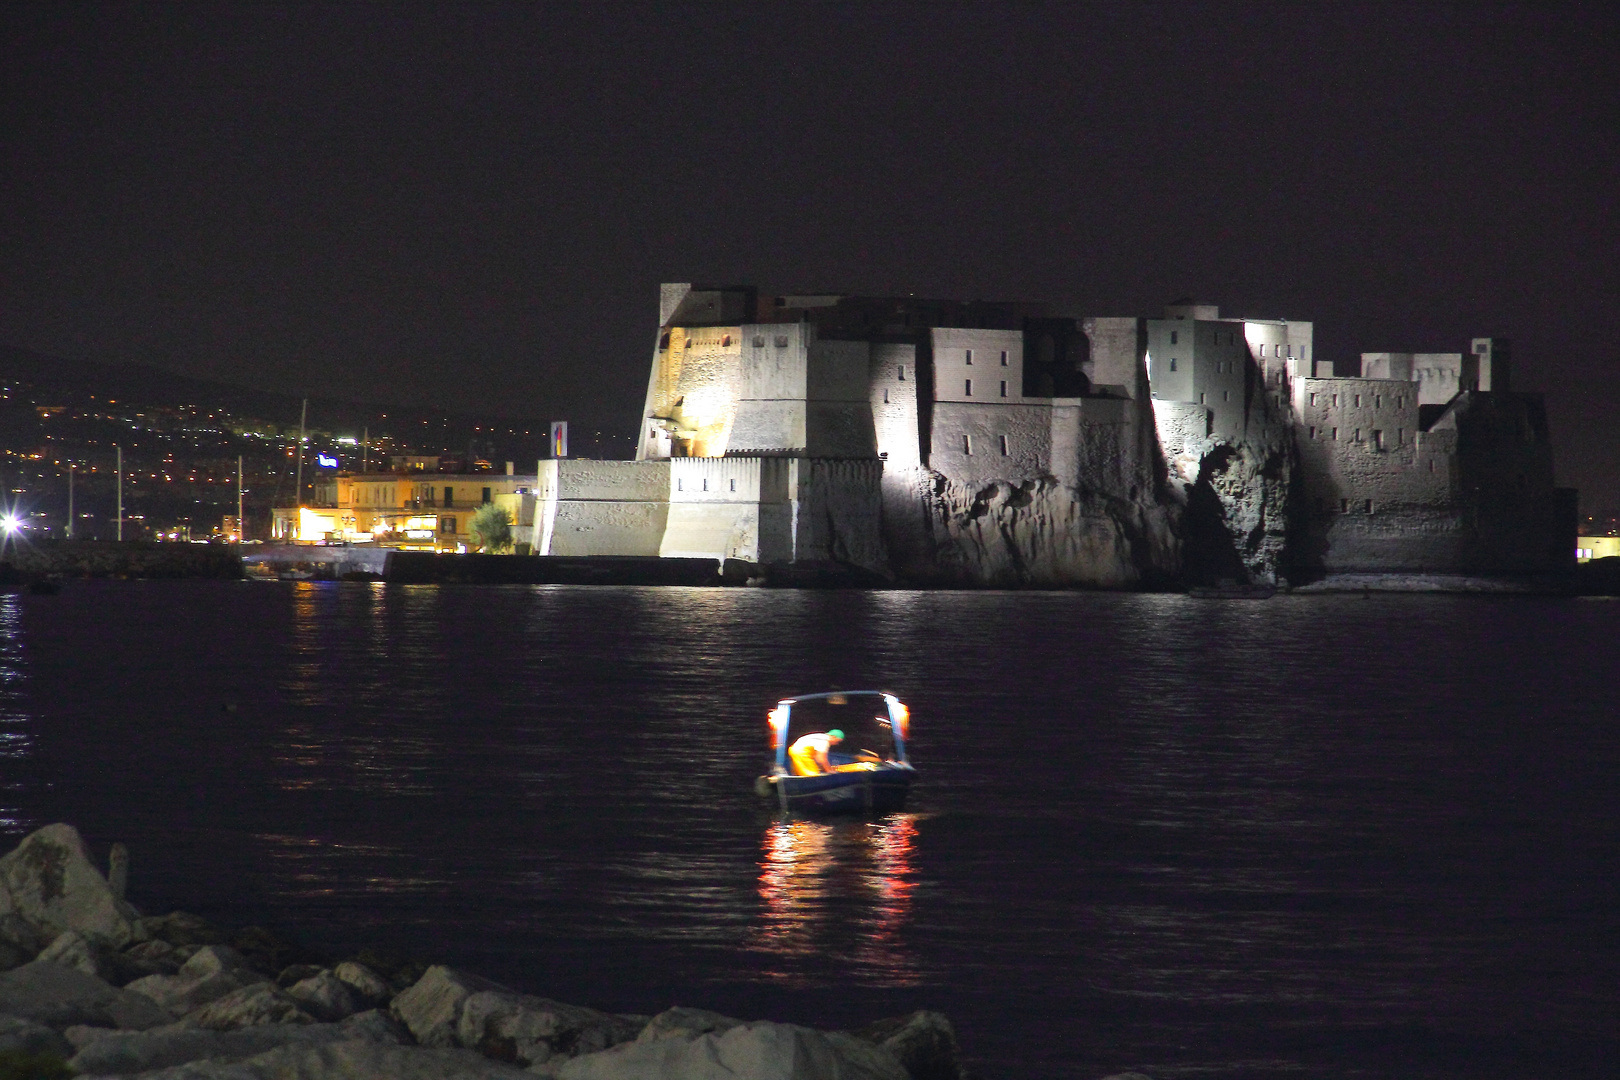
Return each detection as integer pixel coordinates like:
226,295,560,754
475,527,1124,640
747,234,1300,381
753,690,917,814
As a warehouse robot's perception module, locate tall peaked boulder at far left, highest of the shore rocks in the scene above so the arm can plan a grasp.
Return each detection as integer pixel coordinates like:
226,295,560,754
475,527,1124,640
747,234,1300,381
0,824,139,946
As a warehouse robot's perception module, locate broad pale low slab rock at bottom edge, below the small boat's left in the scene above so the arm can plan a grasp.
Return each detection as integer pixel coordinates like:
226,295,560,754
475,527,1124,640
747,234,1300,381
554,1022,909,1080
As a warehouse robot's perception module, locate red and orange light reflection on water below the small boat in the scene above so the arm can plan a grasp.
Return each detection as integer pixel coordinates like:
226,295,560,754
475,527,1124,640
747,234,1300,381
750,814,922,986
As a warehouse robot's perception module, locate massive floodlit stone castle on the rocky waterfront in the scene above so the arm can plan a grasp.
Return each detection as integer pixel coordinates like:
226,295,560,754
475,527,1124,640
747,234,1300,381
533,285,1575,586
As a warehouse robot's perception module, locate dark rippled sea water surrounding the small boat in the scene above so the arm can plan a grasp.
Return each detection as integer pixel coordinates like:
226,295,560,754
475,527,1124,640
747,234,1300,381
0,581,1620,1080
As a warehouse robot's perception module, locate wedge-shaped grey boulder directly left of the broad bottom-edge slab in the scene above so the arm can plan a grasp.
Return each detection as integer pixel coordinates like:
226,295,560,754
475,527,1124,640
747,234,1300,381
455,989,646,1065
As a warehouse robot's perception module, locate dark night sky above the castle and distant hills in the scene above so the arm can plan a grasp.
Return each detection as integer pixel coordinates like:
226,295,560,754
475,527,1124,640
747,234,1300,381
9,3,1620,510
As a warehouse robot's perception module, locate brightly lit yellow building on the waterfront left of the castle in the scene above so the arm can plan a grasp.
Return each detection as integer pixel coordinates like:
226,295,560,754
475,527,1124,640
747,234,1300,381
271,471,535,551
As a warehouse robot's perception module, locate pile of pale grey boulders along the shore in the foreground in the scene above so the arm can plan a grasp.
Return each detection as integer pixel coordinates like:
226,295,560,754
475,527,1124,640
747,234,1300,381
0,824,964,1080
